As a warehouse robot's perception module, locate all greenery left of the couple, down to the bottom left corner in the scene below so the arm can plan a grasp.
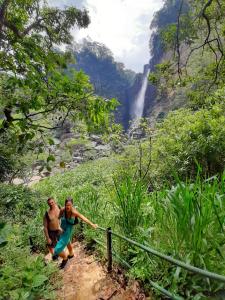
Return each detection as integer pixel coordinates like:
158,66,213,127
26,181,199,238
0,184,59,300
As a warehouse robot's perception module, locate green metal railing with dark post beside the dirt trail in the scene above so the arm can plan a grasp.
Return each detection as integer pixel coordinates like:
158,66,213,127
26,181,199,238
95,227,225,300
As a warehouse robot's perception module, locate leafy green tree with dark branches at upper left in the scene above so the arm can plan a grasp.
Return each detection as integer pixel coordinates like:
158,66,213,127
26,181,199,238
0,0,117,180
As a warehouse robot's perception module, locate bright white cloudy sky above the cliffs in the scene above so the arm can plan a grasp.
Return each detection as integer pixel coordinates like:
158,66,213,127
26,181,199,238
48,0,163,72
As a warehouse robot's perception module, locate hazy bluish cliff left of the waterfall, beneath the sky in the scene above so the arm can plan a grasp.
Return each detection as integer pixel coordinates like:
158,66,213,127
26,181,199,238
70,40,136,129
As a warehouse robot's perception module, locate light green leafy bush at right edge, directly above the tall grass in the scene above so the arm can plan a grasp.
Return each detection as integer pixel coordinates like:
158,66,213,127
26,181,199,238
152,104,225,182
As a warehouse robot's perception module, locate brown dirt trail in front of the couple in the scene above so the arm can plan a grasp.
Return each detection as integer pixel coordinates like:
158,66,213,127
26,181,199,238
47,242,150,300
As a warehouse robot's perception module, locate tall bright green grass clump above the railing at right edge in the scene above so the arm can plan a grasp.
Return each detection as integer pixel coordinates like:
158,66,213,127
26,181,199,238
155,176,225,267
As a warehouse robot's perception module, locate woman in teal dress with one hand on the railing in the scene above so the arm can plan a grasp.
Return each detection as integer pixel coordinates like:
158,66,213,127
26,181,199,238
53,198,98,269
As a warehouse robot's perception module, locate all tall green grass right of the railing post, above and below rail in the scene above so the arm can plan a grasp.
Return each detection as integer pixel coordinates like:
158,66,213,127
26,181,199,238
104,174,225,299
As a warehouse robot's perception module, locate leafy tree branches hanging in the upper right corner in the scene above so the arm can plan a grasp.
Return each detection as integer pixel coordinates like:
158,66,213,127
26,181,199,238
151,0,225,108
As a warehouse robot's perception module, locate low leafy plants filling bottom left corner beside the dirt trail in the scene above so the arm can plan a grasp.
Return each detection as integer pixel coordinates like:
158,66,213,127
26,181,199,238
0,225,56,300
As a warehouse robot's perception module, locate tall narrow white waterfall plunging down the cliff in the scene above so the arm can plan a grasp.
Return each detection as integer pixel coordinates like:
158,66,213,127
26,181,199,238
131,68,150,122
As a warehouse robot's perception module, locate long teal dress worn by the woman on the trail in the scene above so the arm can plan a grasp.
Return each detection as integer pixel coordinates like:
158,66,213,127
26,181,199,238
54,214,75,255
